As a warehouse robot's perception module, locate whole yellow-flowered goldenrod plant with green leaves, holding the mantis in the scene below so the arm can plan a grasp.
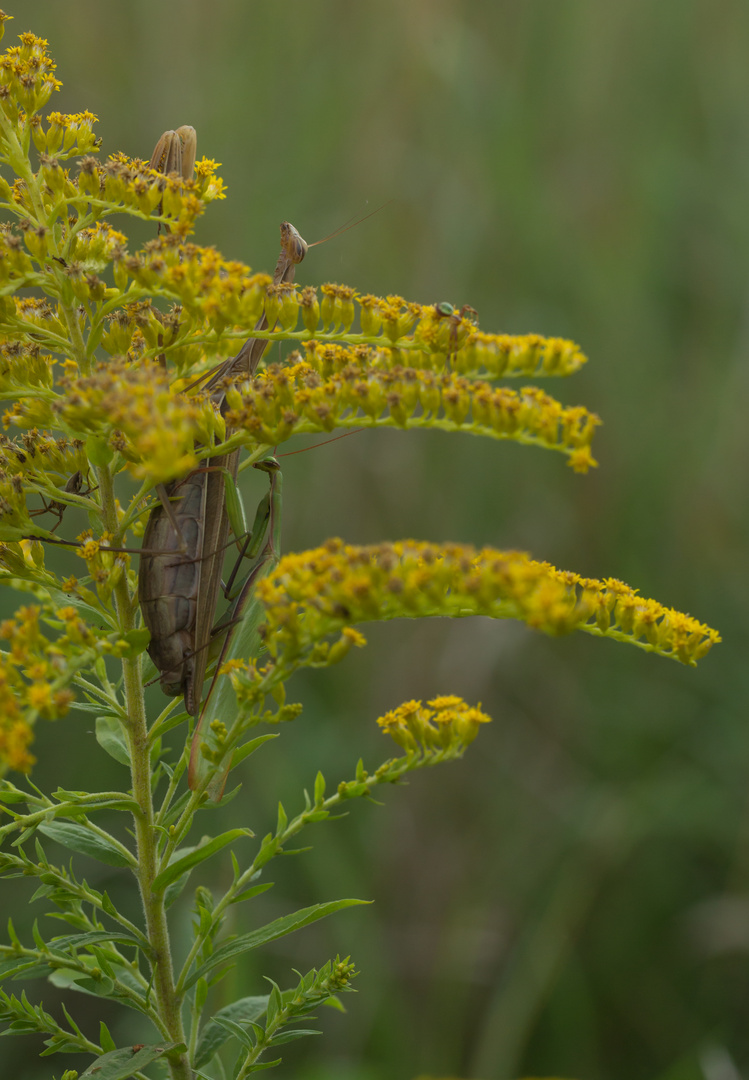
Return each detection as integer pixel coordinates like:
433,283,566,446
0,13,720,1080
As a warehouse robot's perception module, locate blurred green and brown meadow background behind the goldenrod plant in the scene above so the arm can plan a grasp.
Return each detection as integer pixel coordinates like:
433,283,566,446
2,0,749,1080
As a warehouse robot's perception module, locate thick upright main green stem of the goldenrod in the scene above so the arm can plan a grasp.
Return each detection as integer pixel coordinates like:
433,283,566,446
97,467,191,1080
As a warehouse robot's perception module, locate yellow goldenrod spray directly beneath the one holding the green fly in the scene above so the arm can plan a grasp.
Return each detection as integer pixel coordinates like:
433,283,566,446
227,346,600,472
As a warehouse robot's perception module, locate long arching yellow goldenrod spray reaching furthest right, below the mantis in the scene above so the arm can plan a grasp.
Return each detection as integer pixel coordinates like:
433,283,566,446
257,540,720,667
